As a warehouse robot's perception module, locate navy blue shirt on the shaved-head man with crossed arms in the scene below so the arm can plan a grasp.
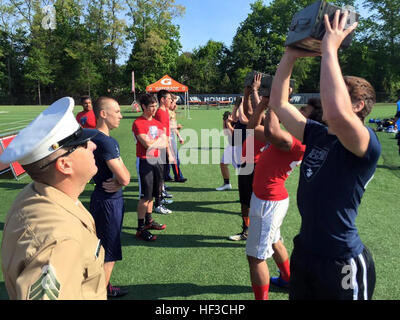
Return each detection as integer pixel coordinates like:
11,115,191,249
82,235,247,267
92,132,122,199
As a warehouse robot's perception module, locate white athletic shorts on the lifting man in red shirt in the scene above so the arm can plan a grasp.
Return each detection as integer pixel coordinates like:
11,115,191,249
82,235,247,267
246,192,289,260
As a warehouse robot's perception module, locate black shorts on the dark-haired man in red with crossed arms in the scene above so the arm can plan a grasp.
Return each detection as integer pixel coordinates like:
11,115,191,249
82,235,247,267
136,158,164,200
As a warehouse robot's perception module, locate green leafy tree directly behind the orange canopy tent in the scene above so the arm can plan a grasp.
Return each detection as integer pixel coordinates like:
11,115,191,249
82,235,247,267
124,0,184,91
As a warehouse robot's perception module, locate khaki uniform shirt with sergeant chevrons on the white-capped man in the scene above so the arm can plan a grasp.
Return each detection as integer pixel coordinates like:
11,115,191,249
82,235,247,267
1,182,107,300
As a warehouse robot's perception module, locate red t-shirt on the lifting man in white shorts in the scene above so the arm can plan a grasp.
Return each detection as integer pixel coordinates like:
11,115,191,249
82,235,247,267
253,137,306,201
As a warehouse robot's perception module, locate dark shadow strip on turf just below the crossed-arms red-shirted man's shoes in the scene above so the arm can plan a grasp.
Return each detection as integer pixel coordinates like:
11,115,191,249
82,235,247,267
121,232,245,248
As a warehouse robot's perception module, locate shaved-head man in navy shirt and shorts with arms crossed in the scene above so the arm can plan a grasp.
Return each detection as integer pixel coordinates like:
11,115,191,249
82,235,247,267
90,97,130,297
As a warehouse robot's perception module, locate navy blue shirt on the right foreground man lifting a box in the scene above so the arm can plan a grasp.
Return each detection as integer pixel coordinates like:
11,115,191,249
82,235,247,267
297,120,381,259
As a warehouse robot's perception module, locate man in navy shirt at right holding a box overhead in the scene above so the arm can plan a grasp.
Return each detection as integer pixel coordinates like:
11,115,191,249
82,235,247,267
269,10,381,300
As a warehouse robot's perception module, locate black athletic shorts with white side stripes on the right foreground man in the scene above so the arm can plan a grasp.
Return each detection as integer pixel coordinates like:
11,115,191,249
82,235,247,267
289,236,376,300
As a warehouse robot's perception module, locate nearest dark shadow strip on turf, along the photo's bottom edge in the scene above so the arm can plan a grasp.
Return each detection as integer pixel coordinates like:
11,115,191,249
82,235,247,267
117,283,252,300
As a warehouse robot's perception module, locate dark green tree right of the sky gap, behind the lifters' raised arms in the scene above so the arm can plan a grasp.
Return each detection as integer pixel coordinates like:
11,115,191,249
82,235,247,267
229,0,354,91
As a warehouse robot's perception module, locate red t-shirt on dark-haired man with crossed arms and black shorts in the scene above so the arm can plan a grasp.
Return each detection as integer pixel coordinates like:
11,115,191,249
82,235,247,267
132,116,164,159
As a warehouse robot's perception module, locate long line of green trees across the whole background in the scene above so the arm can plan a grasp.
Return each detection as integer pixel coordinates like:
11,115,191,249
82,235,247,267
0,0,400,104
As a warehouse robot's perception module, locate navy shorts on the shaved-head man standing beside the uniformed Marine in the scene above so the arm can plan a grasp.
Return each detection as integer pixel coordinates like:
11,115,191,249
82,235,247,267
90,192,125,262
